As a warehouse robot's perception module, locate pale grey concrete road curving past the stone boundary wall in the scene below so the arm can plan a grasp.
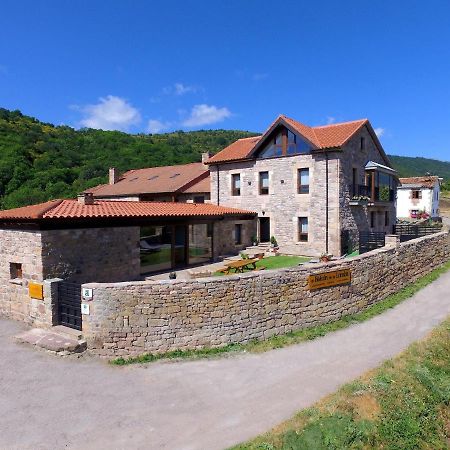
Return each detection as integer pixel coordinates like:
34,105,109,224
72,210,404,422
0,273,450,450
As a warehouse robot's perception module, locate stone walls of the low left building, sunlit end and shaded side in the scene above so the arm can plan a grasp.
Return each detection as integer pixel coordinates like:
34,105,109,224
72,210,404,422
0,227,140,326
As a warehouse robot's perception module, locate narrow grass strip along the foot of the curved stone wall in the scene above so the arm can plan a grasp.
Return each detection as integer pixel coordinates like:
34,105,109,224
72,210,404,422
111,261,450,366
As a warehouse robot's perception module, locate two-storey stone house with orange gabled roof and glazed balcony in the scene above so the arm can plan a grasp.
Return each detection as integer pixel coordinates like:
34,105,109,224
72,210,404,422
207,115,397,255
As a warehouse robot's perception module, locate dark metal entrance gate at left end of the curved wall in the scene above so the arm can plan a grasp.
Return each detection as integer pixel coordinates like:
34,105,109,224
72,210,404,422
58,281,81,331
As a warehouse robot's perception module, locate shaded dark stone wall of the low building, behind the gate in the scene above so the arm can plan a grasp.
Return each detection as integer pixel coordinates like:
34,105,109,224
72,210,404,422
42,227,140,283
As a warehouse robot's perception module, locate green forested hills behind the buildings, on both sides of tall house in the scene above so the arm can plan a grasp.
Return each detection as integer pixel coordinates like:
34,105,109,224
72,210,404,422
0,108,450,209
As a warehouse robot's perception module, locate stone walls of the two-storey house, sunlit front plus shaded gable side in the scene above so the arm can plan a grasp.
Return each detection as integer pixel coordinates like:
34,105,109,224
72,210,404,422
210,123,395,256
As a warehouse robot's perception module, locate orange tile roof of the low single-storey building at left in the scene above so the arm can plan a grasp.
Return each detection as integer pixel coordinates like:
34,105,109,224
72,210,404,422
0,200,256,221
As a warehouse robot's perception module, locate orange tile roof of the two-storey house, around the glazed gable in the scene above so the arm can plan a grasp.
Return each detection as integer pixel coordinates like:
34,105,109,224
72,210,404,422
207,115,368,164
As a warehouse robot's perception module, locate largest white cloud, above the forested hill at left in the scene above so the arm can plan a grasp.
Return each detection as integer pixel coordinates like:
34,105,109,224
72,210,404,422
75,95,141,131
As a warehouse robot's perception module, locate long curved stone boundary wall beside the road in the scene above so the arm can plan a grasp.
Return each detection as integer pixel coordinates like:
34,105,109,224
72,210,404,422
83,232,450,356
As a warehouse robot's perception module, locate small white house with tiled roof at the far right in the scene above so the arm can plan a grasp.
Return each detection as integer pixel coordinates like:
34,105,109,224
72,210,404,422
397,176,442,219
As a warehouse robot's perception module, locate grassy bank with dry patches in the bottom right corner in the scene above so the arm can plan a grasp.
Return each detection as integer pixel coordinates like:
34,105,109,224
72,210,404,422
235,319,450,450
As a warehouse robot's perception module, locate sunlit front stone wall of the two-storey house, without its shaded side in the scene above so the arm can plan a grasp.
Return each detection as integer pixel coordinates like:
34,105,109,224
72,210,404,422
211,153,340,255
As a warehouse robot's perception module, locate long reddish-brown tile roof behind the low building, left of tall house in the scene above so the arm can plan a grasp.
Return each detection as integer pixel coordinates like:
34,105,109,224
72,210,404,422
86,163,209,197
